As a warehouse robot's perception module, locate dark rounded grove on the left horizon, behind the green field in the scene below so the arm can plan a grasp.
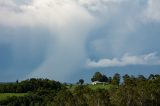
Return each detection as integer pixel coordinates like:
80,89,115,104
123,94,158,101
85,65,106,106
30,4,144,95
0,78,61,93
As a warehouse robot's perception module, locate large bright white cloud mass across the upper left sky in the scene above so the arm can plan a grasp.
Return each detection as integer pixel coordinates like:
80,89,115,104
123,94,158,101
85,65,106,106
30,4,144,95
0,0,95,28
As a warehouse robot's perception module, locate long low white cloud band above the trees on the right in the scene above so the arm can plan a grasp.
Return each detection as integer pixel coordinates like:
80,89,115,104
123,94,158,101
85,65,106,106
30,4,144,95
87,53,160,67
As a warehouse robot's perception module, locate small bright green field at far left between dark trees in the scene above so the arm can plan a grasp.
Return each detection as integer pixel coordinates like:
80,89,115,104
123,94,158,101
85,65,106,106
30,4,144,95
0,93,27,100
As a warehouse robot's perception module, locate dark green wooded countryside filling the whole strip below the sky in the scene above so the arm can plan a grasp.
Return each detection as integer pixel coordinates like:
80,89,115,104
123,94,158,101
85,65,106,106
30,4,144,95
0,72,160,106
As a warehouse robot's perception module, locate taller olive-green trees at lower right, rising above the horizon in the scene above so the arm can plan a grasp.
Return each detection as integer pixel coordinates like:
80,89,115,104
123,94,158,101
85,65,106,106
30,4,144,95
110,74,160,106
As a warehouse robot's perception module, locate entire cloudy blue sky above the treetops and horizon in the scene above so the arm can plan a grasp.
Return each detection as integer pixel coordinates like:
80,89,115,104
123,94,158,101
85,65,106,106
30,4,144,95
0,0,160,82
